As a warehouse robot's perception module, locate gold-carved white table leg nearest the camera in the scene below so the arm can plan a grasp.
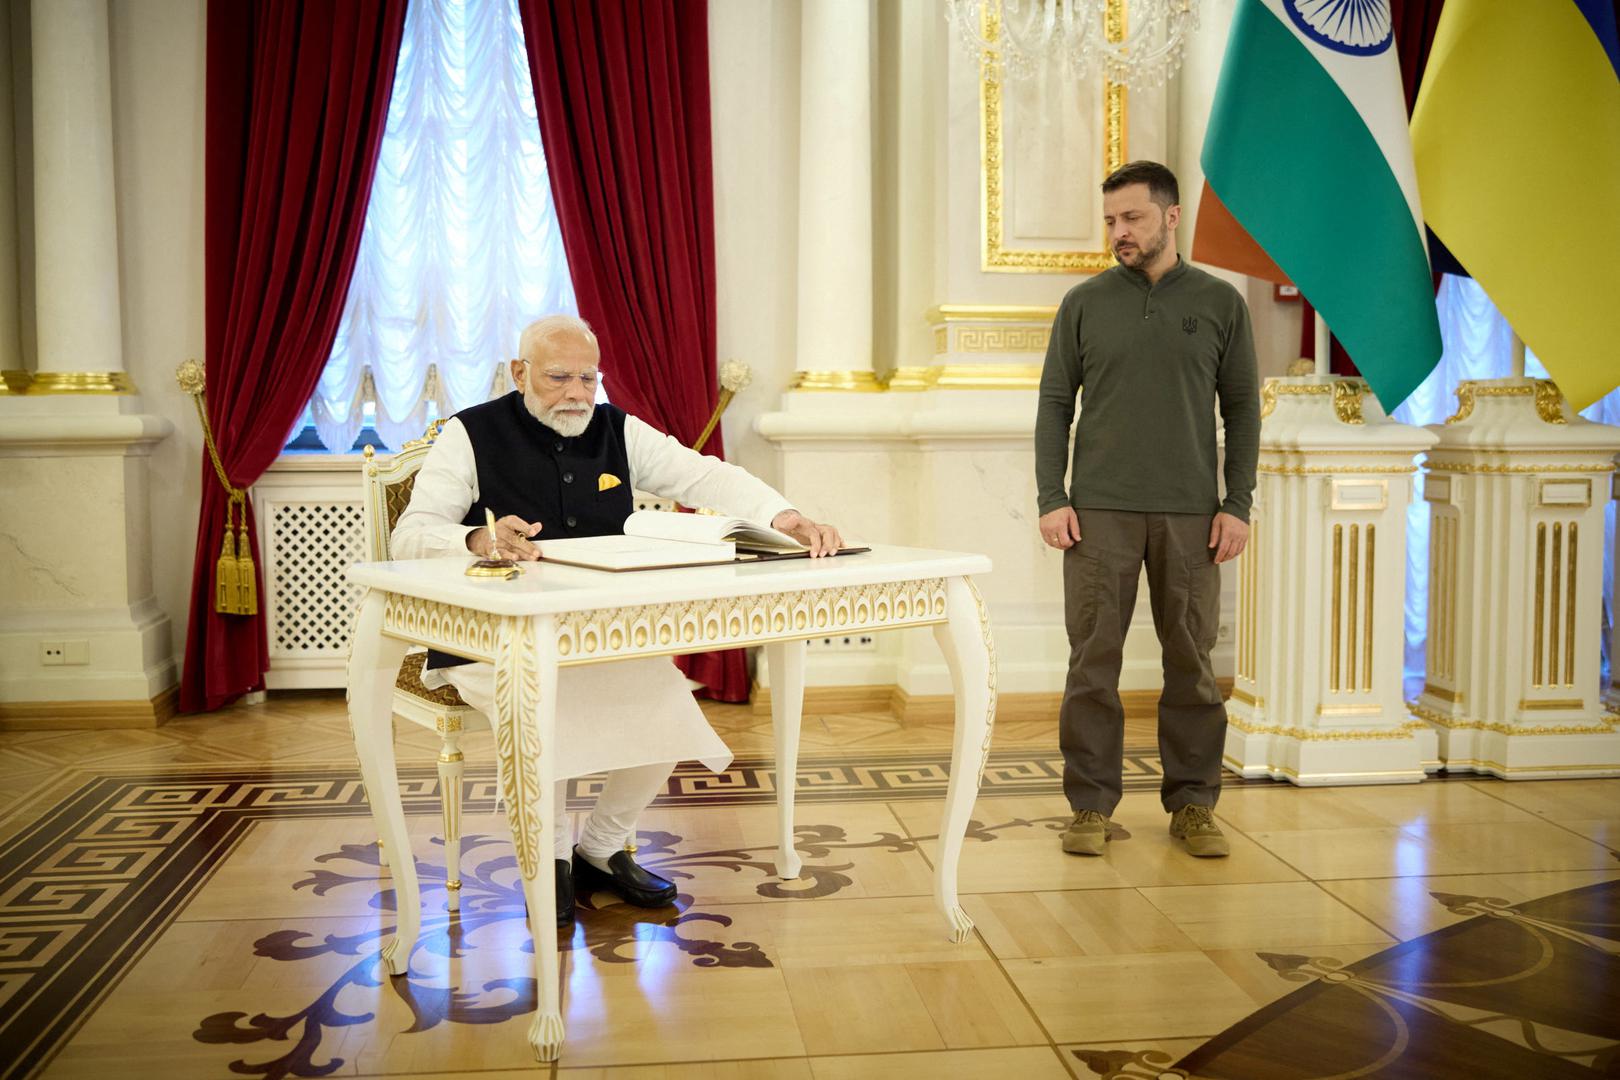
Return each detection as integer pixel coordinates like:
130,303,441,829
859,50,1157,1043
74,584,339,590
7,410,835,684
492,615,562,1061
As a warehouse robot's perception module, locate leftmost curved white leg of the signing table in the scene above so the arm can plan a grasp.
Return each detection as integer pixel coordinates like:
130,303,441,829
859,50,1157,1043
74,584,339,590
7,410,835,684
348,589,421,975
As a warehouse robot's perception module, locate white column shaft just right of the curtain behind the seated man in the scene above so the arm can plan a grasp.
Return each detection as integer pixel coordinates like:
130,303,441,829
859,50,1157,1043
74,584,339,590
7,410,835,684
795,0,876,390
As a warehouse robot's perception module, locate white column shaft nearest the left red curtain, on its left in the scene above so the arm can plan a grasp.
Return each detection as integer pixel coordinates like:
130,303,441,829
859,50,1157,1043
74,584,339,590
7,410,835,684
32,0,128,392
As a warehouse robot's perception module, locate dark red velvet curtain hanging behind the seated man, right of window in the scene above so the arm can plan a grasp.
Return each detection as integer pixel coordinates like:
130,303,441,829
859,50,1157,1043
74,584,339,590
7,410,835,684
518,0,748,701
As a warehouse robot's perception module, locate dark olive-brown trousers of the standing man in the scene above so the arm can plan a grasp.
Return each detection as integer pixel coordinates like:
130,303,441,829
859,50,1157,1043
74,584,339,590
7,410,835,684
1058,510,1226,814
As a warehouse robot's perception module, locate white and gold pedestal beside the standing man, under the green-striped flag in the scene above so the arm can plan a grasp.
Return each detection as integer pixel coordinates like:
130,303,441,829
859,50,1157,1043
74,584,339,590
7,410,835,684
1226,376,1435,785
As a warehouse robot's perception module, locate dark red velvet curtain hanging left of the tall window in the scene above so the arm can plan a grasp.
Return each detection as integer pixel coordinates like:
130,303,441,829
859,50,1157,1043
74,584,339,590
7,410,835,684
180,0,405,712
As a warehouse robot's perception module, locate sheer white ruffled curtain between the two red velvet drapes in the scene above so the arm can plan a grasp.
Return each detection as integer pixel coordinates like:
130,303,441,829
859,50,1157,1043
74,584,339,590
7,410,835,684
309,0,577,452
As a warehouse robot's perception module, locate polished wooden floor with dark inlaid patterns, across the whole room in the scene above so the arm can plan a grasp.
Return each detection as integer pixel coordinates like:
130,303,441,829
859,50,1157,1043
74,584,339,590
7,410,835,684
0,704,1620,1080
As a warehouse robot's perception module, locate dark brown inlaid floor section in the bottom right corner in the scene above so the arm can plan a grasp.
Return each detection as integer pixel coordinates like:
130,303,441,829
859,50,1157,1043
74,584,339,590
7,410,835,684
1170,881,1620,1080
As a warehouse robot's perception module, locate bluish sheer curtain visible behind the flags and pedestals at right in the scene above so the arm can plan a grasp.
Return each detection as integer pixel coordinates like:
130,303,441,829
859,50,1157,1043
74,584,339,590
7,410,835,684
1393,274,1620,698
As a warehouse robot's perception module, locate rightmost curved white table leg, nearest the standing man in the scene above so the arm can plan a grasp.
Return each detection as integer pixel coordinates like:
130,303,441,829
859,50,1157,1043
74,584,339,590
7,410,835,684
933,578,996,941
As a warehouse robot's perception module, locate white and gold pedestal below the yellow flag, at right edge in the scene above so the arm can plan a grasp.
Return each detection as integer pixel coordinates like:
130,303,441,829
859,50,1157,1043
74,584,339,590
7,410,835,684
1414,379,1620,779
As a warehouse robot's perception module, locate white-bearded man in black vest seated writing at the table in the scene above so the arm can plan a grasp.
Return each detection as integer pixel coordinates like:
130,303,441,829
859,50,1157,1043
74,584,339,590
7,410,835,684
390,316,841,929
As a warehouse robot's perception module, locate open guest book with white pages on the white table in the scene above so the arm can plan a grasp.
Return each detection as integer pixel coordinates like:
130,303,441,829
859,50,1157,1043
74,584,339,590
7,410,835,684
535,510,872,570
